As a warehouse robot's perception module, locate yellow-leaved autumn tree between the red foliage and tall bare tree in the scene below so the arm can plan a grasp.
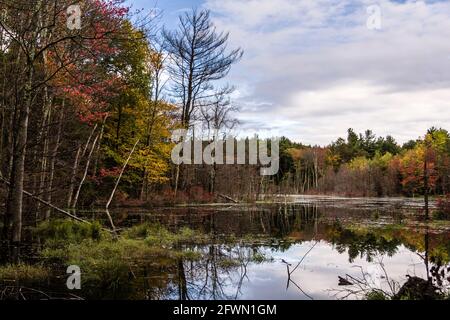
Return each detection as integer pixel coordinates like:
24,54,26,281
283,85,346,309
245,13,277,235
99,24,173,200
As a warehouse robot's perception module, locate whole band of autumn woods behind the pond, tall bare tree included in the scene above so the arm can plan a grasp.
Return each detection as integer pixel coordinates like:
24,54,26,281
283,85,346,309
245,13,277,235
0,0,450,248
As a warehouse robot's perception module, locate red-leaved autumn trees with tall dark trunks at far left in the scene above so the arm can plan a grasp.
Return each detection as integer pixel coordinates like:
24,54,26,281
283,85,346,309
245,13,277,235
0,0,152,255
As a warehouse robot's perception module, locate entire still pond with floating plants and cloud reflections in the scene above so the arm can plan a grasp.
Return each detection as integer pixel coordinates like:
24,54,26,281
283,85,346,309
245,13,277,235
0,199,450,300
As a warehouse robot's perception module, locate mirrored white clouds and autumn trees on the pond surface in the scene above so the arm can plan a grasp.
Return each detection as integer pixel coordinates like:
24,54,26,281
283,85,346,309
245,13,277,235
127,205,450,300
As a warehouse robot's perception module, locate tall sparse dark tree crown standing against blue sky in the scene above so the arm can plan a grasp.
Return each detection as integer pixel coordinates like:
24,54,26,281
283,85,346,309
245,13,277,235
163,9,243,128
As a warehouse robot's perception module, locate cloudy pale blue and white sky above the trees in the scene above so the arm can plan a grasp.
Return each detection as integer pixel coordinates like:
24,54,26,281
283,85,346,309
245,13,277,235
129,0,450,145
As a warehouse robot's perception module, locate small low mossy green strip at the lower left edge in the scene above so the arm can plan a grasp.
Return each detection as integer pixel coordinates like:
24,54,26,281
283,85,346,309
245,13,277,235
0,264,51,283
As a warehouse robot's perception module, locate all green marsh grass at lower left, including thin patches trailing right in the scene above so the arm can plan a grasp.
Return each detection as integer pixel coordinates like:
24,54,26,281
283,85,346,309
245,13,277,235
0,220,274,299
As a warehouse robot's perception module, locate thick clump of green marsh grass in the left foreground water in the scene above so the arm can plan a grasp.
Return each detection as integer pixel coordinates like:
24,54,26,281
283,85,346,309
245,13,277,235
22,220,208,298
